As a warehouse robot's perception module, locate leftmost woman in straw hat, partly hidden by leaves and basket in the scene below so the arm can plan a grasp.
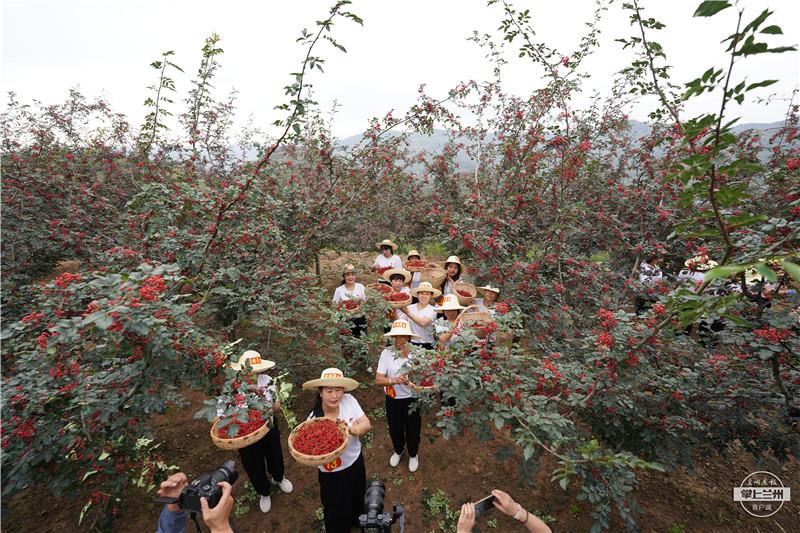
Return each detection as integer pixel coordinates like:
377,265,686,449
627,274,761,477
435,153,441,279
218,350,293,513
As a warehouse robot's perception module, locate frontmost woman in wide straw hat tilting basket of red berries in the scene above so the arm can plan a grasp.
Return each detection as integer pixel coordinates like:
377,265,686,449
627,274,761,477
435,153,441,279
303,368,372,533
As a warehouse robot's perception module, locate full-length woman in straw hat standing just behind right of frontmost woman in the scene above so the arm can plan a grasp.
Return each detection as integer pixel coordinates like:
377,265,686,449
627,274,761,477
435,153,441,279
375,318,425,472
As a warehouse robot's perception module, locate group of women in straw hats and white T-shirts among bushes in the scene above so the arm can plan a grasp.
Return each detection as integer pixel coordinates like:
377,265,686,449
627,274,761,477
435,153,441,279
222,240,500,533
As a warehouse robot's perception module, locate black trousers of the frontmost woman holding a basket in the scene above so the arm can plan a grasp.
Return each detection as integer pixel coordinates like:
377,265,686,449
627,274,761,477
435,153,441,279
317,455,367,533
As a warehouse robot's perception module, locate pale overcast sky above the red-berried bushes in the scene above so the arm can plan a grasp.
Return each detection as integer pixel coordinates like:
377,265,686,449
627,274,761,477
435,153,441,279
2,0,800,136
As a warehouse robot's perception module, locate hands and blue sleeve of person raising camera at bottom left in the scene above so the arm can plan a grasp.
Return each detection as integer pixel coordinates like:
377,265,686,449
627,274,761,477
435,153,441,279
156,472,233,533
